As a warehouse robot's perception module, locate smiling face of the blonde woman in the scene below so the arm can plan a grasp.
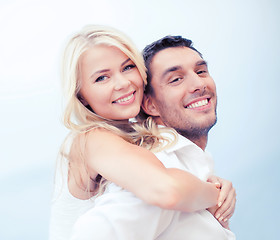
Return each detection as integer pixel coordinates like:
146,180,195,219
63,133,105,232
80,45,143,120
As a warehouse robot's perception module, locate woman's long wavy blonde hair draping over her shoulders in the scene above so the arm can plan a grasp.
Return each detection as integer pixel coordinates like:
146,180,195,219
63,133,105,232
60,25,175,197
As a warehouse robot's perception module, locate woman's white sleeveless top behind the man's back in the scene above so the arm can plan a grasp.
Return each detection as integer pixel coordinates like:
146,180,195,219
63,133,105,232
49,161,95,240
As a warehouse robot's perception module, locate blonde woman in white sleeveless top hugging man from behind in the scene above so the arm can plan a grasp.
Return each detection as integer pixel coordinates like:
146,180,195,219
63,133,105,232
50,26,234,239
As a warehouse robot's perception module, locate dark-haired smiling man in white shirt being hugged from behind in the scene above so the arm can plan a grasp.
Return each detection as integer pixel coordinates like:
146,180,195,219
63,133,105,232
73,36,235,240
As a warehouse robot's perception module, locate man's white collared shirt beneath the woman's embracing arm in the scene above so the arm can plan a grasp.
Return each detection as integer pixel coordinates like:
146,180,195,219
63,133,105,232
71,132,235,240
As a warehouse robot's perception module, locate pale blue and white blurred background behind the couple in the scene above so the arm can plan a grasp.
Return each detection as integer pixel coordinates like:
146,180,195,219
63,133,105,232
0,0,280,240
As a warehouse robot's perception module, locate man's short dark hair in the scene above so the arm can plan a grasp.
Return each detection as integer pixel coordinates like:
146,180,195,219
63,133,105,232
142,35,202,95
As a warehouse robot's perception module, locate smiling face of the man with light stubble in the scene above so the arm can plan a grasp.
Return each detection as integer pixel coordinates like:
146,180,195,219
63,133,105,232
146,47,217,138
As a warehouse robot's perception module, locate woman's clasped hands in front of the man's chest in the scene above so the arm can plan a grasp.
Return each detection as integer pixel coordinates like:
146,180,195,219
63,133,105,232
207,176,236,229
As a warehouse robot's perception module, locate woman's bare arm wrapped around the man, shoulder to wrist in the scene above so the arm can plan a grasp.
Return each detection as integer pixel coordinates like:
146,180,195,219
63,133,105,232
70,129,219,212
